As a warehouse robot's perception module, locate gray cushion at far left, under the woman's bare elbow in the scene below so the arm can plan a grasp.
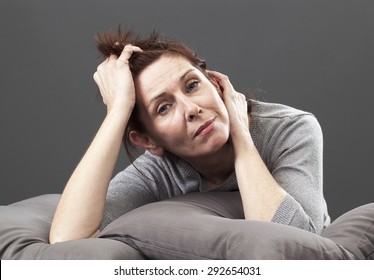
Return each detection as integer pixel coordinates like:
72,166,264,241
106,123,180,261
0,194,143,259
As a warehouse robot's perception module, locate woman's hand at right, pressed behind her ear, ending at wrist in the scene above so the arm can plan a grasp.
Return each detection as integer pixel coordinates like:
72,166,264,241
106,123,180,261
208,71,250,144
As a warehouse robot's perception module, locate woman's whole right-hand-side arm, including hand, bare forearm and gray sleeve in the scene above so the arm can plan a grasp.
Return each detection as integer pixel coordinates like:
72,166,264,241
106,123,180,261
207,72,329,233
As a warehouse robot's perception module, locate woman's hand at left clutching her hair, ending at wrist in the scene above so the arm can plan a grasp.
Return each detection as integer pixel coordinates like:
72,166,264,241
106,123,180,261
93,43,142,112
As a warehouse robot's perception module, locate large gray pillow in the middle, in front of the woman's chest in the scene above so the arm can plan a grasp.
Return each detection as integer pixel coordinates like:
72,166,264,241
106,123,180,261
100,192,354,259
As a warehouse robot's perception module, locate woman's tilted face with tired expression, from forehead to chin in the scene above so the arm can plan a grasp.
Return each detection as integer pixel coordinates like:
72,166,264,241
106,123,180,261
135,55,229,160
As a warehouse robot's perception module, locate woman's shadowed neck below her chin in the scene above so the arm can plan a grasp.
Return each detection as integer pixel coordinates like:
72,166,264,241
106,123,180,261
188,141,235,189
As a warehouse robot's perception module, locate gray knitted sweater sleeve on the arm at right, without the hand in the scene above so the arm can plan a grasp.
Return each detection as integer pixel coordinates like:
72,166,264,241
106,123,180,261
269,114,327,233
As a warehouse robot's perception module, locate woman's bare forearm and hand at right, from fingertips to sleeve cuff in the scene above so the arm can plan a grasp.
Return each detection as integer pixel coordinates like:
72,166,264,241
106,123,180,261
210,71,286,221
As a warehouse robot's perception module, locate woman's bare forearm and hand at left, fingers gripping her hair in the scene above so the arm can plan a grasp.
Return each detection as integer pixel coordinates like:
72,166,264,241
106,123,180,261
50,45,141,243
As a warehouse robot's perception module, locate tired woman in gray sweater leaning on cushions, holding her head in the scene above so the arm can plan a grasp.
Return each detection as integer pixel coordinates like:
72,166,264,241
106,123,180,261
50,30,329,243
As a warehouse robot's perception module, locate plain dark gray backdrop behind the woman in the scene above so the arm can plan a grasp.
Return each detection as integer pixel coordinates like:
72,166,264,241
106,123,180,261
0,0,374,218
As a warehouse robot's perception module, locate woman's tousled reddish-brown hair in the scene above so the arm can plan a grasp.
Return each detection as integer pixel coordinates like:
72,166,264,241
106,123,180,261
95,27,209,161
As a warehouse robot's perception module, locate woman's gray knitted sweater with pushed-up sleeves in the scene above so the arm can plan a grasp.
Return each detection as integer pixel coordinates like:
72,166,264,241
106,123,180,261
101,101,330,233
